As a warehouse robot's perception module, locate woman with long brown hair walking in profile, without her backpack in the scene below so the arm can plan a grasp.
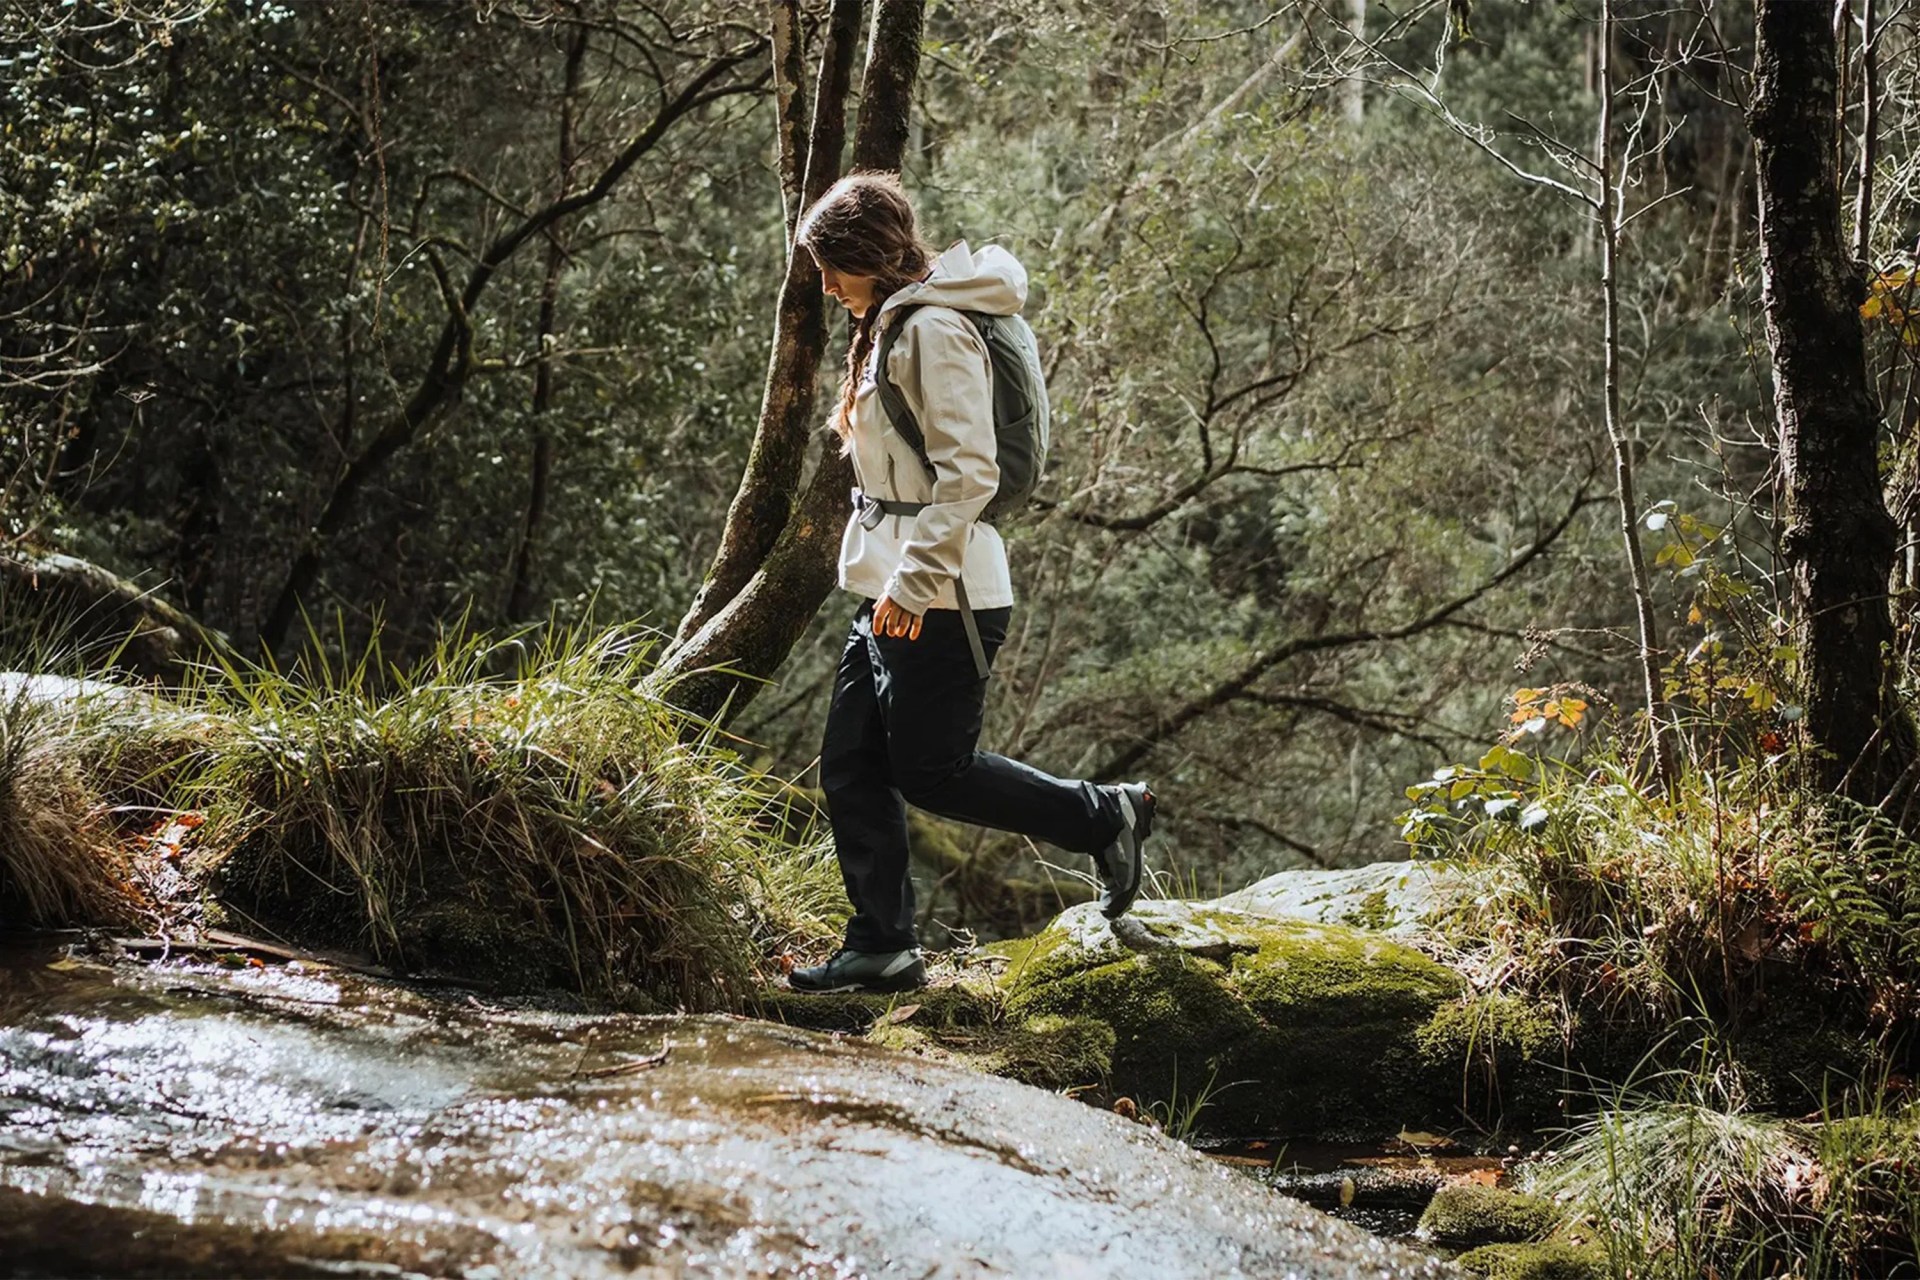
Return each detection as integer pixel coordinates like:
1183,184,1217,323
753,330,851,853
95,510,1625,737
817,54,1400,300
787,175,1154,992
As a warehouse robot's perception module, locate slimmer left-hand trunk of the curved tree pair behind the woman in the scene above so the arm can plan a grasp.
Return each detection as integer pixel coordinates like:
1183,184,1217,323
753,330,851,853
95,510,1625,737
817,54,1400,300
674,0,866,651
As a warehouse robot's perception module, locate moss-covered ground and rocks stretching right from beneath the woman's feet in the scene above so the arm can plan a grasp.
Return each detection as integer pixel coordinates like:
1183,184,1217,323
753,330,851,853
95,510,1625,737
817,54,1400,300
758,912,1557,1138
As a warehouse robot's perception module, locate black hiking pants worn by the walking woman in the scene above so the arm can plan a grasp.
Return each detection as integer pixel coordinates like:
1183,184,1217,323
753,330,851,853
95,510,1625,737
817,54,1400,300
820,601,1121,952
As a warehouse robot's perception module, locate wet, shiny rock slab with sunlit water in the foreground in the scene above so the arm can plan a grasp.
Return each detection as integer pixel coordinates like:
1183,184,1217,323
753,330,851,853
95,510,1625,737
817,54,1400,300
0,946,1453,1280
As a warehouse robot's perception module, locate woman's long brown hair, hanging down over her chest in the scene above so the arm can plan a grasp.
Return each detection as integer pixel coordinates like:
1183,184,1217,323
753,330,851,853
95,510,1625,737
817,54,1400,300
795,173,933,439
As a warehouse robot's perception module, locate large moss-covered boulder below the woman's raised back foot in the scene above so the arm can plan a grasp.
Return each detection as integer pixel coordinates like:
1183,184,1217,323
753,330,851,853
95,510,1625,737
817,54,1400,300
991,902,1532,1138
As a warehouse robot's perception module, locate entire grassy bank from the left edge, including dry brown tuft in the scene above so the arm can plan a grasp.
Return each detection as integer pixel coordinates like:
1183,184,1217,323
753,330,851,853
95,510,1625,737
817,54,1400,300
0,614,847,1009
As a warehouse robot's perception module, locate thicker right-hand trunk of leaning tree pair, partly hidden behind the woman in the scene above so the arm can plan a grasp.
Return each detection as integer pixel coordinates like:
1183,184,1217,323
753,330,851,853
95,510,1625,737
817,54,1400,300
659,0,925,720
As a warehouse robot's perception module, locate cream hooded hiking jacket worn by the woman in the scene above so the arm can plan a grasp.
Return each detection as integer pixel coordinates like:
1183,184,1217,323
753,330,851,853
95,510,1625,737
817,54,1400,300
839,240,1027,614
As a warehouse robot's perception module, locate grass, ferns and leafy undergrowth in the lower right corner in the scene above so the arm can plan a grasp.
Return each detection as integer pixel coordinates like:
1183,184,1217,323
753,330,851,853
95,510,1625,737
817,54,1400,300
1404,667,1920,1280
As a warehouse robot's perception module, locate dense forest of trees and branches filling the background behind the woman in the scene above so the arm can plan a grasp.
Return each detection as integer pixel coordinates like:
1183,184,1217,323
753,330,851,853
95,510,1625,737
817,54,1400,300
0,0,1920,929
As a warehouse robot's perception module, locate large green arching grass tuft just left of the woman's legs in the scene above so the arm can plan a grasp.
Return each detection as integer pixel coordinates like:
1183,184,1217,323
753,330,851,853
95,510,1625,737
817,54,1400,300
161,631,839,1007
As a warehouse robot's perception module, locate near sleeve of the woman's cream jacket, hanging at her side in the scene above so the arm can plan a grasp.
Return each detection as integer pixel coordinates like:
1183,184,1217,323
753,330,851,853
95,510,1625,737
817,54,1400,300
887,307,1000,614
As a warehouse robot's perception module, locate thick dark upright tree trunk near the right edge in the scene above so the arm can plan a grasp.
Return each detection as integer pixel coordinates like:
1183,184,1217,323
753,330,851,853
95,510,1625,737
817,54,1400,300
1749,0,1914,802
